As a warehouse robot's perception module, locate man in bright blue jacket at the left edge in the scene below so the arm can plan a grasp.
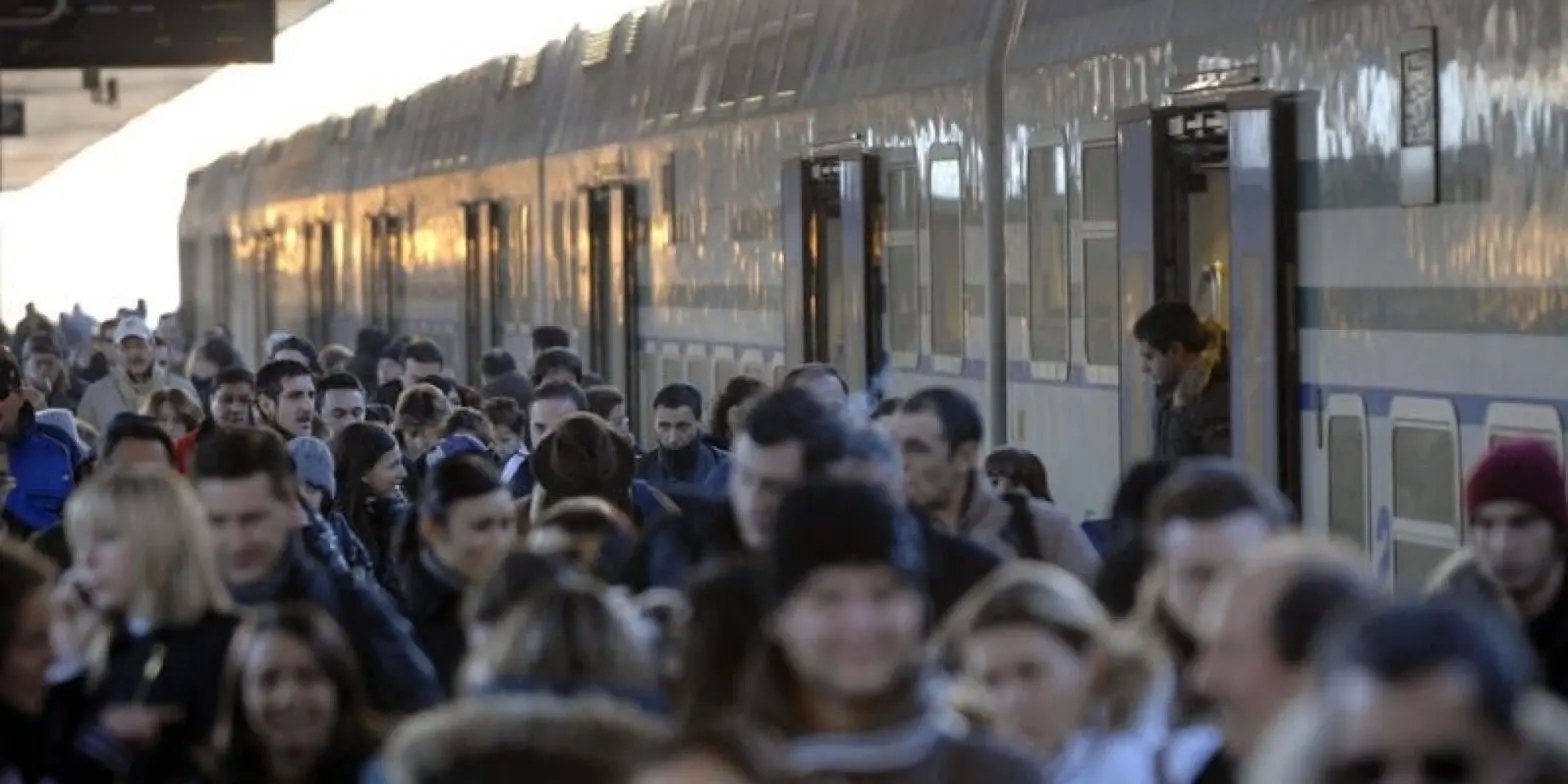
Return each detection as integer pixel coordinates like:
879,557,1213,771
0,356,83,548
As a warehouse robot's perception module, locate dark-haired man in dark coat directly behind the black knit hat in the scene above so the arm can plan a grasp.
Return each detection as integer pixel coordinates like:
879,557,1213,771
626,389,848,591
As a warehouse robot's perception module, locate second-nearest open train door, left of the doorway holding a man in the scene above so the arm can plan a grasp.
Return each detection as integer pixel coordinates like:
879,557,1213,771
782,152,886,387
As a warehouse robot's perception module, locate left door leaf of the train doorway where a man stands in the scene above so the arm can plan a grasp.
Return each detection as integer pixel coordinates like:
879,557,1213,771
1116,105,1174,466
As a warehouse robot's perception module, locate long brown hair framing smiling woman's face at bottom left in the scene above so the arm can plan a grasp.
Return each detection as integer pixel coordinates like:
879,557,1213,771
204,604,381,784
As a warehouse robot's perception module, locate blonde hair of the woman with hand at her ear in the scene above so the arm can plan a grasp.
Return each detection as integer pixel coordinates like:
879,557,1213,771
64,467,234,627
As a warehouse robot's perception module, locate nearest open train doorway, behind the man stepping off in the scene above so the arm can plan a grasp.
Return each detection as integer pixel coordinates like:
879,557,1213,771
1116,93,1301,500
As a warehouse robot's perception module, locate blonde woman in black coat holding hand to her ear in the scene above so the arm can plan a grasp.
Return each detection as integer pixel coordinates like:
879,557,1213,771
55,470,238,784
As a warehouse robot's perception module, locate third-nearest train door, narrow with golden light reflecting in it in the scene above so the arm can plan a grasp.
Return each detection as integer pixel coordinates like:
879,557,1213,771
580,183,643,409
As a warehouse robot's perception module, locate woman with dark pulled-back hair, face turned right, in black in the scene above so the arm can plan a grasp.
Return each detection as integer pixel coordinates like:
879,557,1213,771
397,455,517,687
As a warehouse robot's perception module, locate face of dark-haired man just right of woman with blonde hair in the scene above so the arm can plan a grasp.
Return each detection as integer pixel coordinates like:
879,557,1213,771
196,474,304,585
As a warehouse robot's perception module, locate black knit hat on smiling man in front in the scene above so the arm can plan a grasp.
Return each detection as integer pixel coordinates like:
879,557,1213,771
770,481,925,602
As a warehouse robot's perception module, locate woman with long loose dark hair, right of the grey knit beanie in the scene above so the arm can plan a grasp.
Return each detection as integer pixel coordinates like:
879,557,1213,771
332,422,409,601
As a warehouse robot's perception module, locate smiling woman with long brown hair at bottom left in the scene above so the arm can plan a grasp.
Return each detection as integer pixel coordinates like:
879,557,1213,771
207,604,381,784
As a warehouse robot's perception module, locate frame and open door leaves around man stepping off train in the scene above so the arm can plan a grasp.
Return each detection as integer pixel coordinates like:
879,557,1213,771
1116,91,1301,503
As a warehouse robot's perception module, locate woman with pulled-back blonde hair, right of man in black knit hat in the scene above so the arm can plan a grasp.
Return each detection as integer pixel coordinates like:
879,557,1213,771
936,561,1174,784
